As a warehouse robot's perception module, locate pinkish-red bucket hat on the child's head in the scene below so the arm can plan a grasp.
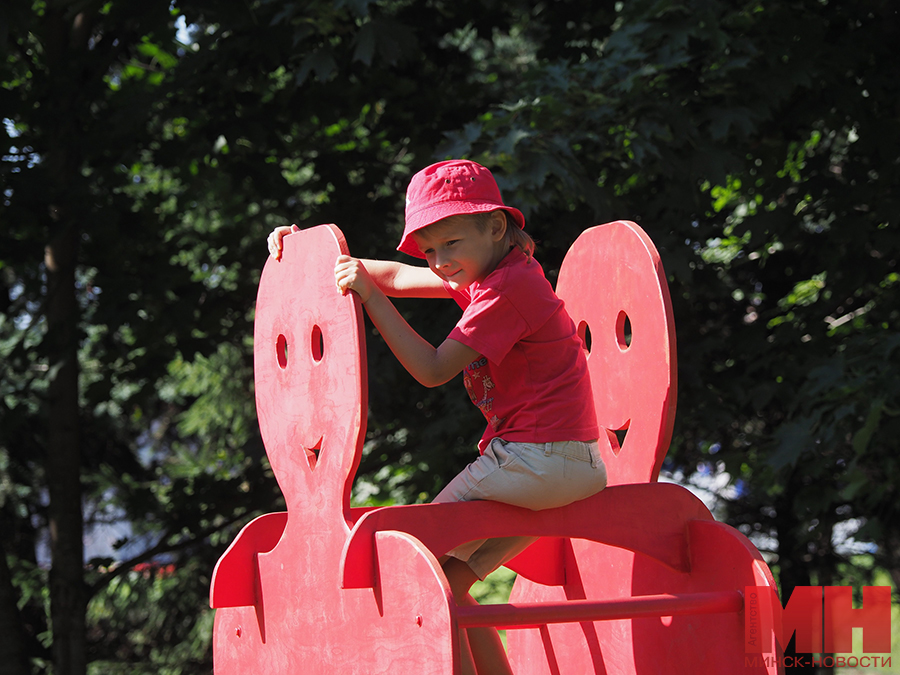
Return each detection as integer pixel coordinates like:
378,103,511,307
397,159,525,258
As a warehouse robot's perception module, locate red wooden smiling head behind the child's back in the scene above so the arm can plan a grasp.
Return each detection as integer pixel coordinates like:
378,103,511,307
556,221,677,485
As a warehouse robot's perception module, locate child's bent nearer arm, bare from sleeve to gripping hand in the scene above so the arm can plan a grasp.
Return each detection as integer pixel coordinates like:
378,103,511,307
334,255,478,387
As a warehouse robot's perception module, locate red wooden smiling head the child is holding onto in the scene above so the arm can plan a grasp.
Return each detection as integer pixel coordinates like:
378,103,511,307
254,225,368,513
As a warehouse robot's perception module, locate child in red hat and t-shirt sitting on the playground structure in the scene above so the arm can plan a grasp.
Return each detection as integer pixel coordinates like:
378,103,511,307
268,160,606,675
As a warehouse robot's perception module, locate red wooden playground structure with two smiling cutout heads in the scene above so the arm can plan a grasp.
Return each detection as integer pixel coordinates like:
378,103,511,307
210,221,781,675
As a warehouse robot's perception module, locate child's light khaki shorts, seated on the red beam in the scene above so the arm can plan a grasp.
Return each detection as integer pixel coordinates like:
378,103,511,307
434,438,606,579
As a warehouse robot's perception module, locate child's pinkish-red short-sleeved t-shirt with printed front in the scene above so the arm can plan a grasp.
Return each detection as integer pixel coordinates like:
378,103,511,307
445,248,599,452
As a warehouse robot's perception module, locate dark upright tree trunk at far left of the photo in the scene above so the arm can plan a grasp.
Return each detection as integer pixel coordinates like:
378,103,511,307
42,2,98,675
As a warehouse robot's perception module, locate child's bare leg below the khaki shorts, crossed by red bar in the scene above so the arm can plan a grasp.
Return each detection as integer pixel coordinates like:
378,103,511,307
442,558,512,675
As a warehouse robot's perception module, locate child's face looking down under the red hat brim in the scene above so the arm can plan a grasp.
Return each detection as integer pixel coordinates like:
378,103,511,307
412,212,509,290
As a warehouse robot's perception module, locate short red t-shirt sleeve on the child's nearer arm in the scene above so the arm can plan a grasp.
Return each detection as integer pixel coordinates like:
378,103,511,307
447,289,531,363
